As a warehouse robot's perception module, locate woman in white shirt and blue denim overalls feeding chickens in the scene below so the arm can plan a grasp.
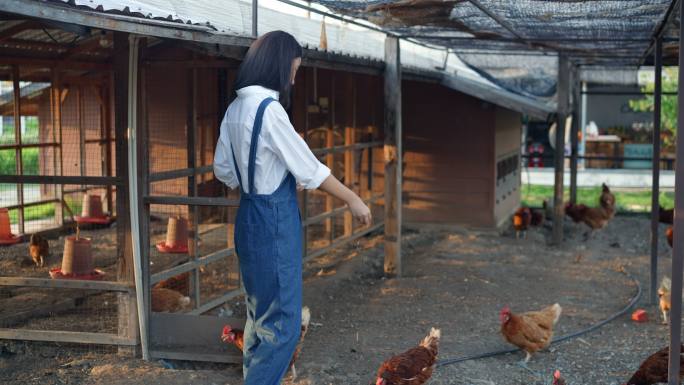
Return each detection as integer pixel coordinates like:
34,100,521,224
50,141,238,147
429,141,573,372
214,31,371,385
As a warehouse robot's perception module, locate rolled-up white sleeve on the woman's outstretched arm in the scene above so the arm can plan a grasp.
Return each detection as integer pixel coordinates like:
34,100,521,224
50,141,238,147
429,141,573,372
262,103,330,190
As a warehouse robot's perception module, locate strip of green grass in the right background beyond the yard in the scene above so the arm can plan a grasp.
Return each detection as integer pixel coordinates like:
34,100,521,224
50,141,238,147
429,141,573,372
521,185,674,212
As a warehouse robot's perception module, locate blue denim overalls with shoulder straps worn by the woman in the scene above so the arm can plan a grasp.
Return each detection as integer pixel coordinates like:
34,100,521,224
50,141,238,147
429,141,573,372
233,98,302,385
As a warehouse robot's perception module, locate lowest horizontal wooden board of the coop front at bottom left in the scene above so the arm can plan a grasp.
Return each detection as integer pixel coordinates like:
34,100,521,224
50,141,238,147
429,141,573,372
0,328,137,346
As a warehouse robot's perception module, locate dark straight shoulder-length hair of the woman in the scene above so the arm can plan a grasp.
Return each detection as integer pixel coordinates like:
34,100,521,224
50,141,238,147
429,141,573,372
233,31,303,109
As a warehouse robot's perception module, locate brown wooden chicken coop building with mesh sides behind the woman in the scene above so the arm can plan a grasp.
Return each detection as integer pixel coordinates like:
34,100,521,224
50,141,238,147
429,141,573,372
0,1,552,361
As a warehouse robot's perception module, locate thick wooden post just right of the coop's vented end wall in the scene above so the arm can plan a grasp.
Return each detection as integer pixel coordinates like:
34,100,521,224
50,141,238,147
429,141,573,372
552,53,570,245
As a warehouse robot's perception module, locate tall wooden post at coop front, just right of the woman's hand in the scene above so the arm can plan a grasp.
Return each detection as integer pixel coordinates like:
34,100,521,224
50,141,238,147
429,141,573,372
384,36,402,276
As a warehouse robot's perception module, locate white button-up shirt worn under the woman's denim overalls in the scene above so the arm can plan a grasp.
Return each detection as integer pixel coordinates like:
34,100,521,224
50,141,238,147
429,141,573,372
214,86,330,194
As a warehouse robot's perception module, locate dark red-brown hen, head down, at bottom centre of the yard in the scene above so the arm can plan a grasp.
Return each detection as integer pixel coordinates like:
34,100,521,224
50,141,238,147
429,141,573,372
375,328,441,385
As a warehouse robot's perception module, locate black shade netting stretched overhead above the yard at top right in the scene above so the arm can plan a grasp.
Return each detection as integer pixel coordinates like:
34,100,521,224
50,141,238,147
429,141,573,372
317,0,678,99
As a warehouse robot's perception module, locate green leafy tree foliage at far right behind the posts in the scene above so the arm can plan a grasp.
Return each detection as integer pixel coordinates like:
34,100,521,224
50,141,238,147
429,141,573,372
629,67,679,147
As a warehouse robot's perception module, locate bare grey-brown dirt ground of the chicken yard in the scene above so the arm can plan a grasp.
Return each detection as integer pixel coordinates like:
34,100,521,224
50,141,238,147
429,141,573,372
0,216,671,385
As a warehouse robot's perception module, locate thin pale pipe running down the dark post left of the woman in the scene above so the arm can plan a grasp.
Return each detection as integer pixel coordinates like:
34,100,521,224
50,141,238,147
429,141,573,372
128,35,150,360
